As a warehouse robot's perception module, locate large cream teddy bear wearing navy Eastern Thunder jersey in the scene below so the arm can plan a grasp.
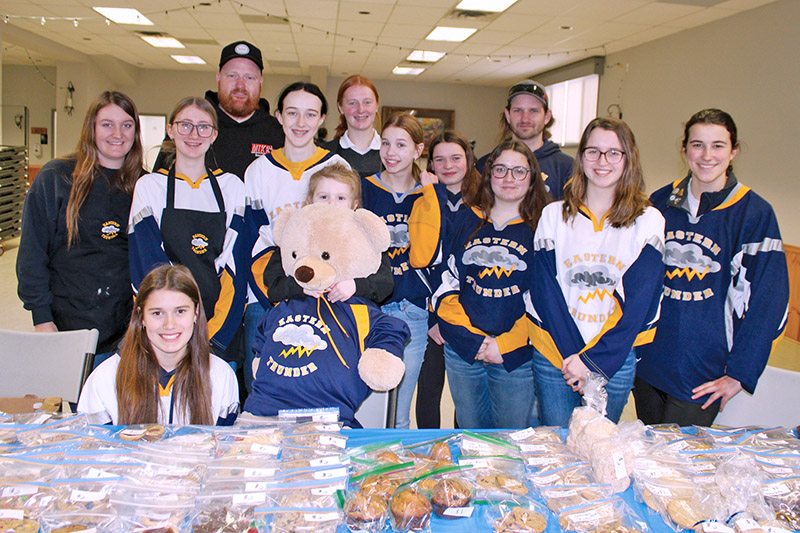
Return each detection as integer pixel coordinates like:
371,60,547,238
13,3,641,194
244,203,410,427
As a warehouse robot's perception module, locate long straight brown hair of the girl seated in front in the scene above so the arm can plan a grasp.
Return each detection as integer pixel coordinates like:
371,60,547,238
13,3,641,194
117,265,215,425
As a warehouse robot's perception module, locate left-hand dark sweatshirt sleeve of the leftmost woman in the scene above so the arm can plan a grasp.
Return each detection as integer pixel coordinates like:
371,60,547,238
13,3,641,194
17,164,61,325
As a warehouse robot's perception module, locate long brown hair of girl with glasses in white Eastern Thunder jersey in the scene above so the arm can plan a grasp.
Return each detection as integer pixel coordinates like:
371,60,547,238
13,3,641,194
562,117,650,228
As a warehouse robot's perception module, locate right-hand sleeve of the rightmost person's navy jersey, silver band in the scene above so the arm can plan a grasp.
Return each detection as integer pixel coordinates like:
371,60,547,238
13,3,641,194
725,206,789,394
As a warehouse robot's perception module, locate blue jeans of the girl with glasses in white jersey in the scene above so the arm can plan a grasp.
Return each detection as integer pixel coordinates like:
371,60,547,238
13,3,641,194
533,350,636,427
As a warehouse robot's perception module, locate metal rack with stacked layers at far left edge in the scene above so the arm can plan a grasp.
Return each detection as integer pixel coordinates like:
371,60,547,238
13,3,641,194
0,146,28,255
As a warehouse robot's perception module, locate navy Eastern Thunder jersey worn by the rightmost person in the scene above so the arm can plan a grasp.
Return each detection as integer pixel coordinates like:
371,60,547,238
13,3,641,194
637,173,789,403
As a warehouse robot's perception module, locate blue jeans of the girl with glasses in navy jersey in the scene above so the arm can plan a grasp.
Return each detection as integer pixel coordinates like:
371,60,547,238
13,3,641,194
444,343,534,429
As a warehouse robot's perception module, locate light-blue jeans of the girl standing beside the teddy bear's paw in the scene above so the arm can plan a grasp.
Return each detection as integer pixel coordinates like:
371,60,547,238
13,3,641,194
381,300,428,429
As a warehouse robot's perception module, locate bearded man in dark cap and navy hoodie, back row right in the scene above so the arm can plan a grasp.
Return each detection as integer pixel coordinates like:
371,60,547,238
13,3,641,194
476,80,573,200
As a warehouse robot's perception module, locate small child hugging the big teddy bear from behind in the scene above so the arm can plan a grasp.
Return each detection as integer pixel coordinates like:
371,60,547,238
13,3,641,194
264,163,394,305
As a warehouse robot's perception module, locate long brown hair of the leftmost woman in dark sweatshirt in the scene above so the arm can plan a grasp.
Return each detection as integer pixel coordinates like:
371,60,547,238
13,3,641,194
65,91,144,246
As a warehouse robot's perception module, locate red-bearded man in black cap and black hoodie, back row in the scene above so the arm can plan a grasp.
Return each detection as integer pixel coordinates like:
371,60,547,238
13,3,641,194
154,41,283,180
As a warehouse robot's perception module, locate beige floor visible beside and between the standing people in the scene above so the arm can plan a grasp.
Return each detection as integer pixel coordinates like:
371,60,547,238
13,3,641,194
0,238,800,428
